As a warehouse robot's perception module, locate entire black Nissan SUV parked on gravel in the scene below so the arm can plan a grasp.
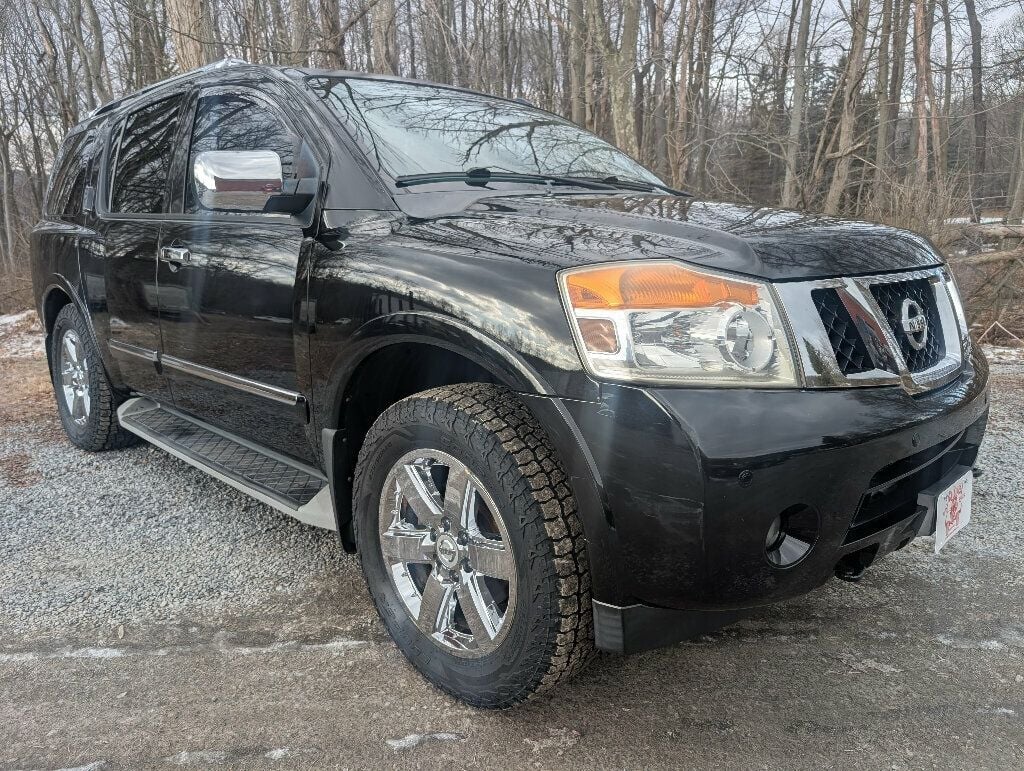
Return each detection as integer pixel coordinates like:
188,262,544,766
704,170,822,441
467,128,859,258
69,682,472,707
33,61,988,706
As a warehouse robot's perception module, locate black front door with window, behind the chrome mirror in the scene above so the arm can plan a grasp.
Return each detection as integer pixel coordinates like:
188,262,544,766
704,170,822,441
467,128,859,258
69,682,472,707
158,87,313,460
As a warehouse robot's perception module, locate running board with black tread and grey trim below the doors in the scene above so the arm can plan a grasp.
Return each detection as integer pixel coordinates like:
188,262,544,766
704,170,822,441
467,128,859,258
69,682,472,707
118,396,337,530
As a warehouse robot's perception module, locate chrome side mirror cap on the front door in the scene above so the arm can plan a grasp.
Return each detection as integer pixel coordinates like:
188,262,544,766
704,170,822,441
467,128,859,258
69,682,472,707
193,149,284,213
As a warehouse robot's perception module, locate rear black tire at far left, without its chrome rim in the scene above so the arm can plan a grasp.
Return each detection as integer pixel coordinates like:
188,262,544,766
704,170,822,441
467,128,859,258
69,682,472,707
49,303,138,452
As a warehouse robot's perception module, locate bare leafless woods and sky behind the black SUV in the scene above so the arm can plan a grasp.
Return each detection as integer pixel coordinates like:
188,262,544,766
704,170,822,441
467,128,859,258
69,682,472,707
0,0,1024,329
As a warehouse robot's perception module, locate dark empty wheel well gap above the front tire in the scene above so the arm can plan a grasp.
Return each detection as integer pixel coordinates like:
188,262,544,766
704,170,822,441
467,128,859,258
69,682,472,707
333,343,499,551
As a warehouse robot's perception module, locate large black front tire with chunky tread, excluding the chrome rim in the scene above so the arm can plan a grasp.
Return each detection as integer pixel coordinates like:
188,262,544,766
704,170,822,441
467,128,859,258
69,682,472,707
353,383,594,709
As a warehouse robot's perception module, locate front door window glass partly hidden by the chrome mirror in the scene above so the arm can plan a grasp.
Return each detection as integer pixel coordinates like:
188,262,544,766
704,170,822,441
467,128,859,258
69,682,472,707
185,94,296,213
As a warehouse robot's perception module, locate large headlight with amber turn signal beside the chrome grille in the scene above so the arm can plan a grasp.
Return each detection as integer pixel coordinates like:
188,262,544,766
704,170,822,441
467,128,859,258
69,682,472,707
559,261,797,388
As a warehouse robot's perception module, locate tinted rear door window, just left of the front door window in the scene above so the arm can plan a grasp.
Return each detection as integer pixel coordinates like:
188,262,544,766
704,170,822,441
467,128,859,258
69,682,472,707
111,96,181,214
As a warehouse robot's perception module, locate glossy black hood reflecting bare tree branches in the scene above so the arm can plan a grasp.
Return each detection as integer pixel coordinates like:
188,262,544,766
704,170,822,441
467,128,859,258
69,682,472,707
391,195,941,281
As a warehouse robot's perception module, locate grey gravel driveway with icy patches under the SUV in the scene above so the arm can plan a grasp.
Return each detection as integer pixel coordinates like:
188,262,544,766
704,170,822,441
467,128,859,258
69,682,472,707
0,309,1024,769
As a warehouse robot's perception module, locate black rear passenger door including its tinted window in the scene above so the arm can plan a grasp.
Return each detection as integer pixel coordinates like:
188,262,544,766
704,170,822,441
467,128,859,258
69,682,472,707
96,93,184,401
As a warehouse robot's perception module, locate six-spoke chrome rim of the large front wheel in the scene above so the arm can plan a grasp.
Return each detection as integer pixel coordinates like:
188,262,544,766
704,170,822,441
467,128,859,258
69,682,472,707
379,449,516,657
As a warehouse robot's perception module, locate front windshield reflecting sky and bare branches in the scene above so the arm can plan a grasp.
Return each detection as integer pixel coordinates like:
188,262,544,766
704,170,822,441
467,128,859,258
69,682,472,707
309,77,662,184
